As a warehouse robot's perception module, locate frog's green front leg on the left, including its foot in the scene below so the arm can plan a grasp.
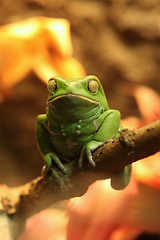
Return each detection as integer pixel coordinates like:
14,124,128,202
36,114,66,173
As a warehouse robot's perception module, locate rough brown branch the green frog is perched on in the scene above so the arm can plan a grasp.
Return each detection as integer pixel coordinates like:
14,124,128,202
0,120,160,239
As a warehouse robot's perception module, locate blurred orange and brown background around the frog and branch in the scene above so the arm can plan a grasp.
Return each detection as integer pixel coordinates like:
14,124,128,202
0,0,160,240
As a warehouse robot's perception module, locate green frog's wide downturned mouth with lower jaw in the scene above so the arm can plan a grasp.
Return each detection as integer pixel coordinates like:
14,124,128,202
47,94,100,120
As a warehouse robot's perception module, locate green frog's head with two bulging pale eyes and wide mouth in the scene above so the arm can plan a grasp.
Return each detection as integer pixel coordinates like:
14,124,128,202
47,75,108,121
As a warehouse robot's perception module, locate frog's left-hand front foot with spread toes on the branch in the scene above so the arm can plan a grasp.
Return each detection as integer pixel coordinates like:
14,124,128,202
42,152,66,175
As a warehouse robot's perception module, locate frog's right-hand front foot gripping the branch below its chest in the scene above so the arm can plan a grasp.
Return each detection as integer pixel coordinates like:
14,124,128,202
79,140,104,167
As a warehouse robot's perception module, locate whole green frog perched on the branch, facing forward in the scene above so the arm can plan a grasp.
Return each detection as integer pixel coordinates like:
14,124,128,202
37,75,131,189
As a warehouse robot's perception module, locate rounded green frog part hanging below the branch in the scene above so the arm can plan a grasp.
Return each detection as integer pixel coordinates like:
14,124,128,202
111,165,131,190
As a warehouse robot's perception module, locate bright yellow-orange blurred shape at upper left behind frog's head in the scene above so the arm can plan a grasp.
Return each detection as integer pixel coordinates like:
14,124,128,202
0,17,85,97
